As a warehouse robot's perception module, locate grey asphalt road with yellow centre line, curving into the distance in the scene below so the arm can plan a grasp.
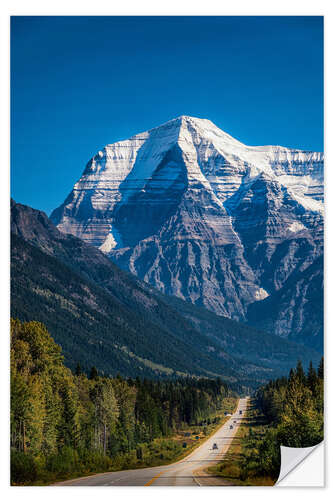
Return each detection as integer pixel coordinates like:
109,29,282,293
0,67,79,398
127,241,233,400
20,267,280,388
55,398,247,486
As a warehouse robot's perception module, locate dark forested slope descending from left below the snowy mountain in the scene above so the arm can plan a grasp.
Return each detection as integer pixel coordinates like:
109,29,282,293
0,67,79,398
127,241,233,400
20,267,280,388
11,201,317,386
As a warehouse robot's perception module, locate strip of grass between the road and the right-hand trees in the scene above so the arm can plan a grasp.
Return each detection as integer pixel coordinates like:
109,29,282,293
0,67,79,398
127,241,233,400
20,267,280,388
207,400,276,486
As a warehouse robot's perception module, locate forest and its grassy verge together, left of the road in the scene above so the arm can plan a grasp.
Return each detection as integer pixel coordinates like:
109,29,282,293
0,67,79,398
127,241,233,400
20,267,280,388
10,320,237,485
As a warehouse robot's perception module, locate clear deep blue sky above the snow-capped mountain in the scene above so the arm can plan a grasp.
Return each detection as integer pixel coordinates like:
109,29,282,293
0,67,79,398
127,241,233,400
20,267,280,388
11,17,323,213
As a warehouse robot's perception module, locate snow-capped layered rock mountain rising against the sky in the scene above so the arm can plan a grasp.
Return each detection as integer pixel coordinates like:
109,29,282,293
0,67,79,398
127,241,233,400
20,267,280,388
51,116,323,336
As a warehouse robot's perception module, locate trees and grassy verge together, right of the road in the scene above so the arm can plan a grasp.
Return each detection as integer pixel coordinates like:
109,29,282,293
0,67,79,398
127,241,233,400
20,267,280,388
208,360,324,486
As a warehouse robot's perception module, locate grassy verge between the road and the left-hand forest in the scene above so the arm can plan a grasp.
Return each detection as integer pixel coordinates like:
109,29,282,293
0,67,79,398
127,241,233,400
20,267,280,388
30,397,238,486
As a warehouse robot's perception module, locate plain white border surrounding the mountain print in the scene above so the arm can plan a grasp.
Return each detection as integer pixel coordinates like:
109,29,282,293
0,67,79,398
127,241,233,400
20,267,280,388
0,0,333,500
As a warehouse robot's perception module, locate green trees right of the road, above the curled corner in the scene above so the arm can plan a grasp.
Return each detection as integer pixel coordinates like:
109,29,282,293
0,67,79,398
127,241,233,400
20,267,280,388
242,358,324,480
